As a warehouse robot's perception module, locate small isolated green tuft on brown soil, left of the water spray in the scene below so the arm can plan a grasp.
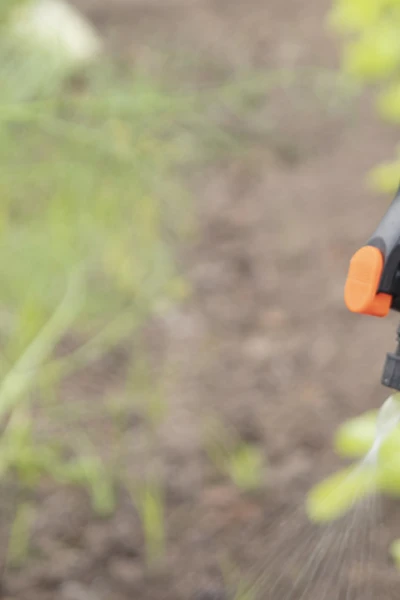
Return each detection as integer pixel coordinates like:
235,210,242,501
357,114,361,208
205,419,265,491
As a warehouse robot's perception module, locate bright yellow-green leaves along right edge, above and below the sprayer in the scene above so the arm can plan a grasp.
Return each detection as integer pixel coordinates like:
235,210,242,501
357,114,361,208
307,0,400,563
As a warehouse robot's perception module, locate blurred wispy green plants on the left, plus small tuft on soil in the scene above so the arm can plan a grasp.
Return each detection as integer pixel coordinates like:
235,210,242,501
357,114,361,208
0,0,368,572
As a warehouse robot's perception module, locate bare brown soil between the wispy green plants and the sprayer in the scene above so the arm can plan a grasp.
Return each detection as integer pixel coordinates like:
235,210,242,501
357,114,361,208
2,0,400,600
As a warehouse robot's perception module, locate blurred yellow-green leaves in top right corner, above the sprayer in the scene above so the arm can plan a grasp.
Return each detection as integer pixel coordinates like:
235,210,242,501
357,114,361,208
330,0,400,193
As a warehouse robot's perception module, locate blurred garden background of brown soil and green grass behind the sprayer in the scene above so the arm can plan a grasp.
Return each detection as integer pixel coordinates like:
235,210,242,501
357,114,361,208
0,0,400,600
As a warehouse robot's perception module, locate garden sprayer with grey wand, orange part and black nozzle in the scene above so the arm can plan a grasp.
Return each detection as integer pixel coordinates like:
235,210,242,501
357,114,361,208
345,187,400,391
